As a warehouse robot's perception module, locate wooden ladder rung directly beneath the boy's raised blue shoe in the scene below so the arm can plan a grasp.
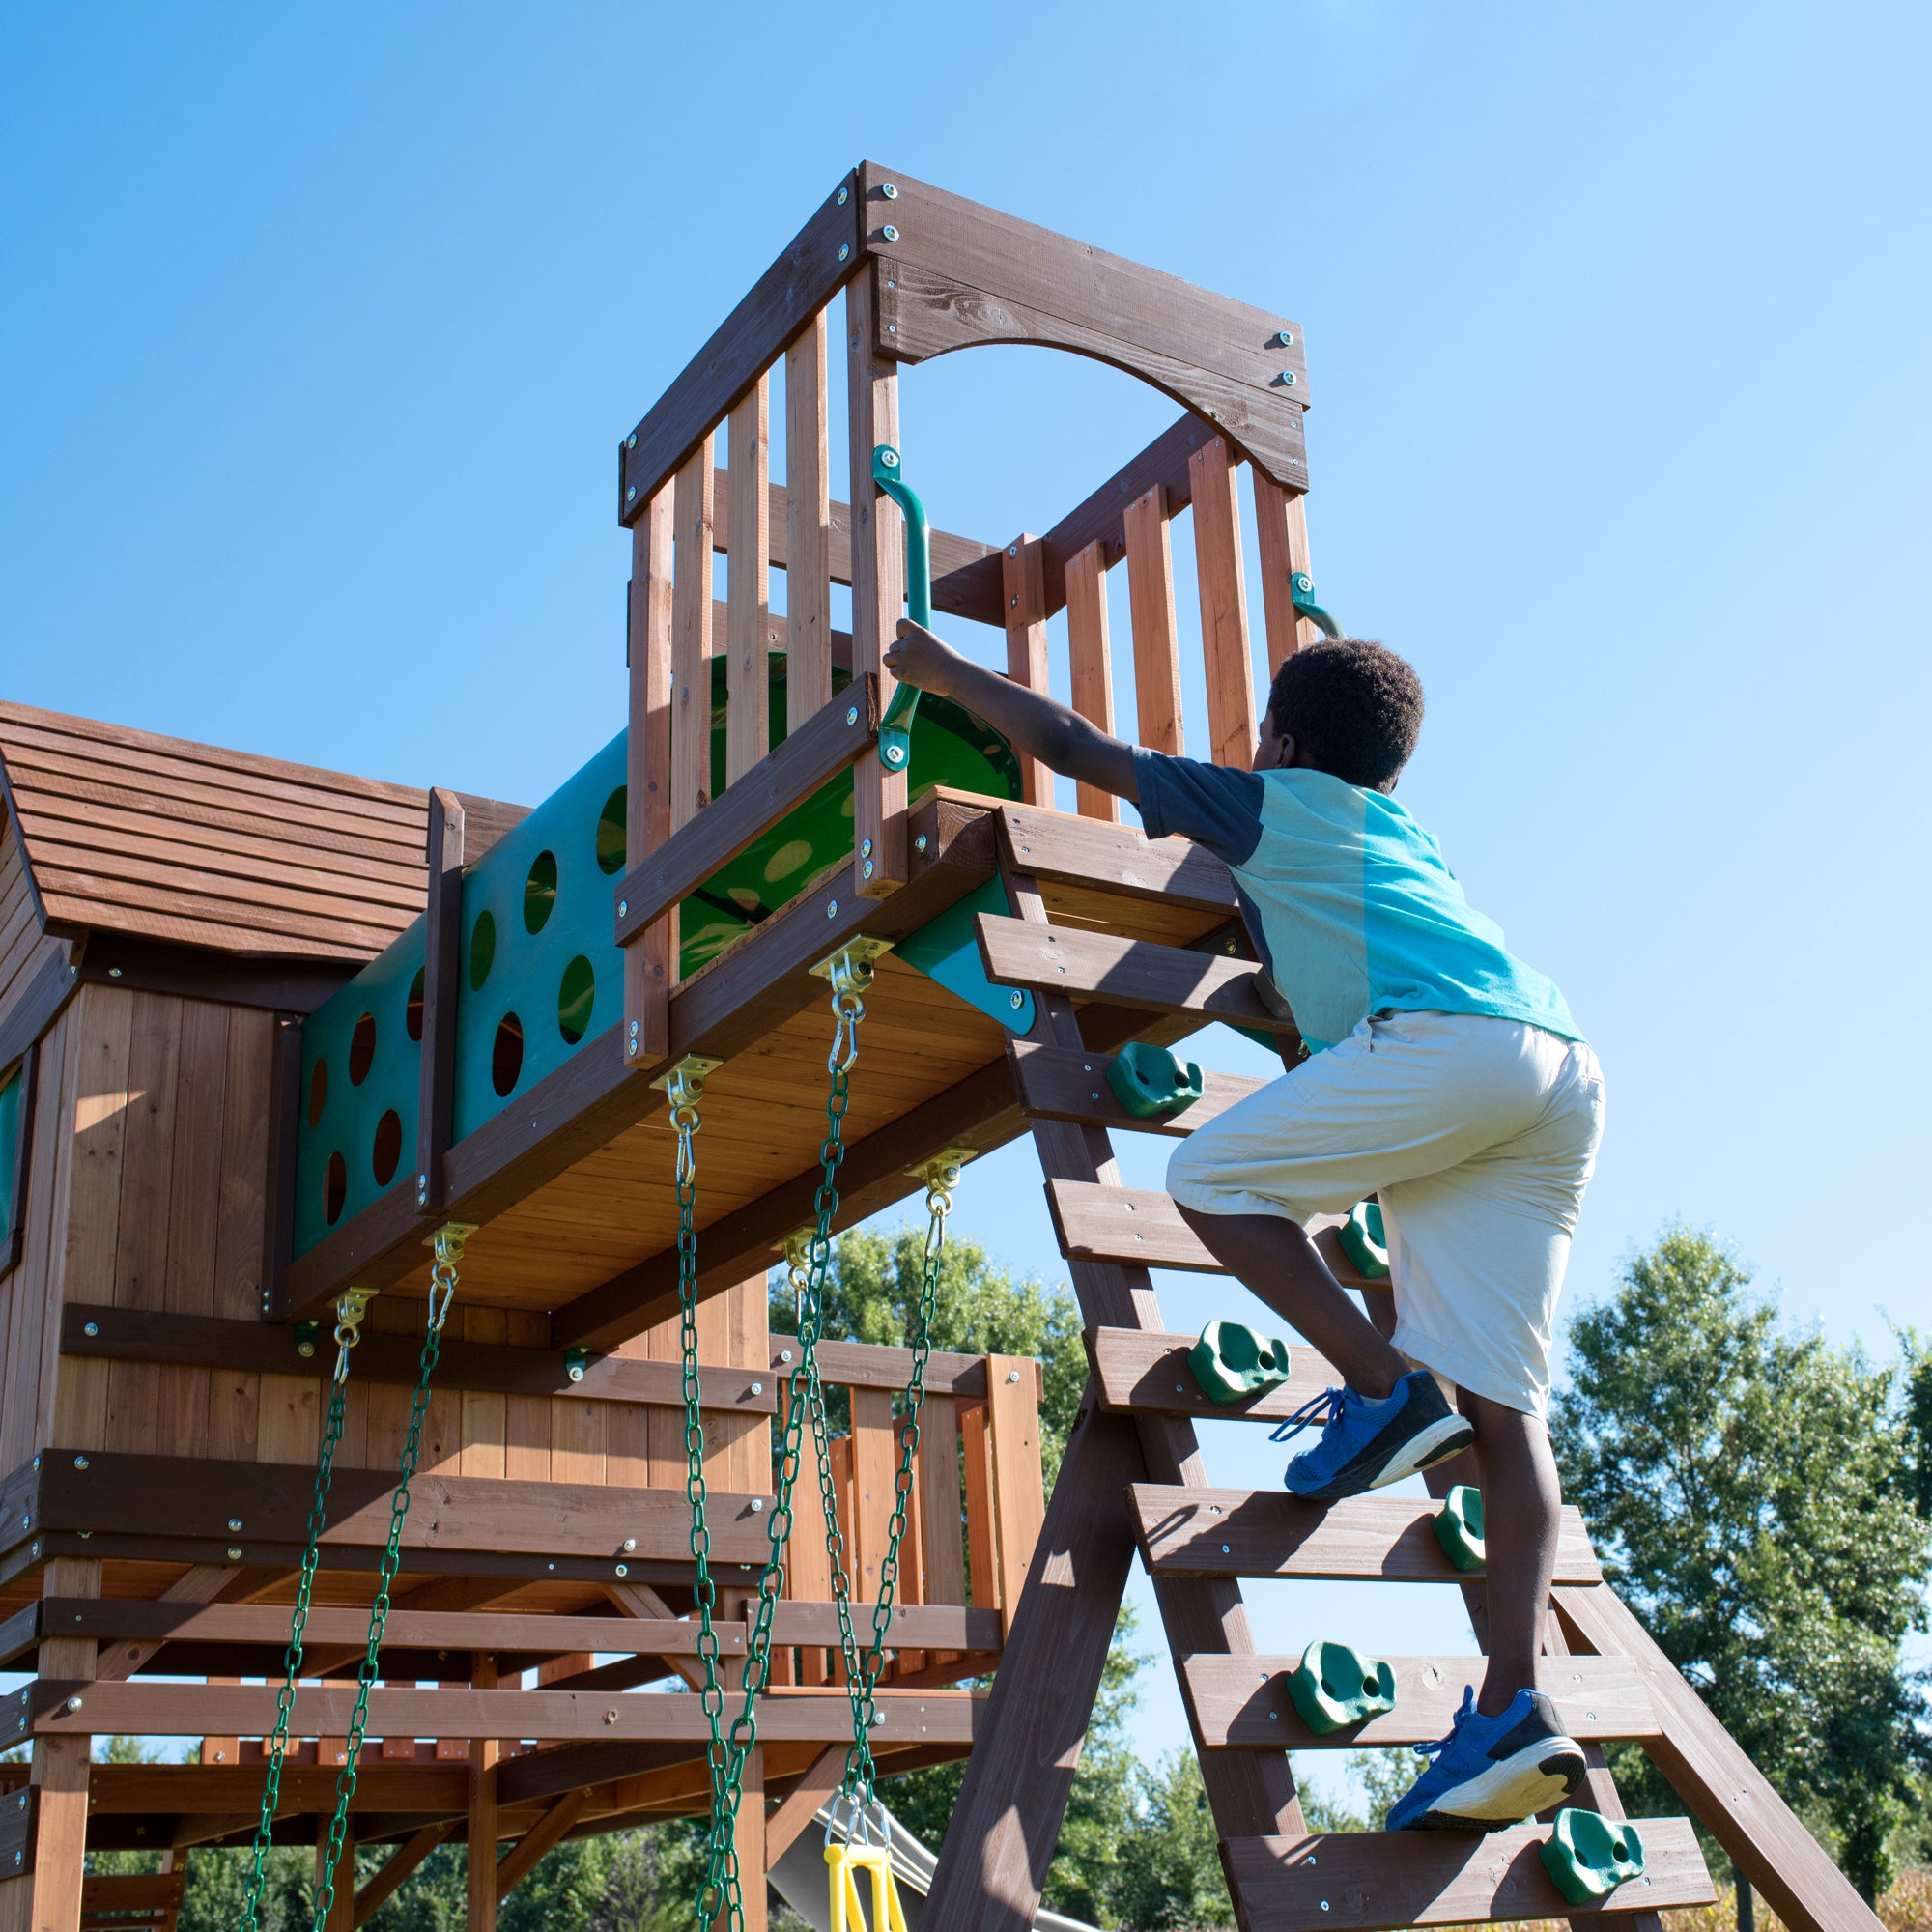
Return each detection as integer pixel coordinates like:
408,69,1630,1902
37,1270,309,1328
1126,1482,1604,1584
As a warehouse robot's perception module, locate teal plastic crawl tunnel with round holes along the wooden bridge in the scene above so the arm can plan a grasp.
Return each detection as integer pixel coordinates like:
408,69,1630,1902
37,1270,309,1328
296,655,1034,1254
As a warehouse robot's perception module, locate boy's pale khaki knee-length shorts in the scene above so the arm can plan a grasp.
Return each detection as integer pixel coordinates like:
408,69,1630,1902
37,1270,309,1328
1167,1012,1604,1416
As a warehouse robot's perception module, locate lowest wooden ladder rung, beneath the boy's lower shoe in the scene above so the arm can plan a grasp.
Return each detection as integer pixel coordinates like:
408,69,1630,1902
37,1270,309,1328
1221,1818,1716,1932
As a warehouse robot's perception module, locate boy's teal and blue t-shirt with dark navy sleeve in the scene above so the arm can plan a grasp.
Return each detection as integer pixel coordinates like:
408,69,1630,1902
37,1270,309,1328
1134,748,1582,1053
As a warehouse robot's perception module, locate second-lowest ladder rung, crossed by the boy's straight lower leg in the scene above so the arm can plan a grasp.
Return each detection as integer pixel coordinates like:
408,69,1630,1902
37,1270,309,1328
1175,1656,1658,1750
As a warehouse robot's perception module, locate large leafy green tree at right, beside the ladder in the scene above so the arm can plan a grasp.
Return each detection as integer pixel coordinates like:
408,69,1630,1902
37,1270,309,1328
1551,1227,1932,1899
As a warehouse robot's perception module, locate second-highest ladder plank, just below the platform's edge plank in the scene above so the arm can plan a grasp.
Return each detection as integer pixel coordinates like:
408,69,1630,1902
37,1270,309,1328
974,912,1296,1037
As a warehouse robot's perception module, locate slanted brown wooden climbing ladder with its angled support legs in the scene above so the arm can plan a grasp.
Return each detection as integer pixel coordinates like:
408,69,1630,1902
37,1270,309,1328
922,885,1878,1932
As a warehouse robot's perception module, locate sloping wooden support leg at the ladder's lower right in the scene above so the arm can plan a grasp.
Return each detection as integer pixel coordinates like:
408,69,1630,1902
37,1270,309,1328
1551,1586,1878,1932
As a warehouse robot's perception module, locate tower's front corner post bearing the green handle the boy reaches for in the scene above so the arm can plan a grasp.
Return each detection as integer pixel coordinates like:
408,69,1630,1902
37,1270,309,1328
846,267,908,898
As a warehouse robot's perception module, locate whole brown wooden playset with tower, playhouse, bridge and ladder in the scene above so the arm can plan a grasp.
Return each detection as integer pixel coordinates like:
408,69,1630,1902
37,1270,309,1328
0,164,1876,1932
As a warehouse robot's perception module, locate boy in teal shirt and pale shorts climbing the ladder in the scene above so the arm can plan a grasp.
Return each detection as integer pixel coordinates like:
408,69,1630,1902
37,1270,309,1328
887,622,1604,1832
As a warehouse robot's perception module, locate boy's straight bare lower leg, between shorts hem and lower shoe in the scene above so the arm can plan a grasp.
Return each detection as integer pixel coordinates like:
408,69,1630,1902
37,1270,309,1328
1459,1389,1563,1718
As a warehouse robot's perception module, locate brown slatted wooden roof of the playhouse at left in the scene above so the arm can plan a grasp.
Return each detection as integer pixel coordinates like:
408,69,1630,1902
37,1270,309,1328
0,701,429,960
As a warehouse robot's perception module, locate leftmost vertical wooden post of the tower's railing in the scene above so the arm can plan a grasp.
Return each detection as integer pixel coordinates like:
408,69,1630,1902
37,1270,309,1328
624,485,680,1070
